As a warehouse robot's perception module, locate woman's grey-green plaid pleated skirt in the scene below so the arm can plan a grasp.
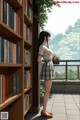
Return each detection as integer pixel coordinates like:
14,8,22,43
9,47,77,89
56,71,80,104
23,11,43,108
40,60,55,80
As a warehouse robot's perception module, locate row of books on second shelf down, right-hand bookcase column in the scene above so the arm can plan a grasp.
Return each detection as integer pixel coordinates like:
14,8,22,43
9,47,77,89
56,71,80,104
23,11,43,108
24,23,32,45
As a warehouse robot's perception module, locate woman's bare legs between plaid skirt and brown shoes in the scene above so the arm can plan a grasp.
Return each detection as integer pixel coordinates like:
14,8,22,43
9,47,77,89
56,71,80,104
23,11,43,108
43,80,52,113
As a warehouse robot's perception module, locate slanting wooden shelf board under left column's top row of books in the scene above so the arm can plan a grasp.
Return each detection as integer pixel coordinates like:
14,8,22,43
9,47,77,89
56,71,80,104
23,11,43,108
0,21,22,43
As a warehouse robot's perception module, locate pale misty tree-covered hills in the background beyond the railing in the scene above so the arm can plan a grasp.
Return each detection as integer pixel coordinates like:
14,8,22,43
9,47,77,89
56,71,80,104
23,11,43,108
49,19,80,60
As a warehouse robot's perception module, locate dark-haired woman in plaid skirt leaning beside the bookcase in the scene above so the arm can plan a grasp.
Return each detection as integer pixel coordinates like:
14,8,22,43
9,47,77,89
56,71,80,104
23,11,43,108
38,31,54,118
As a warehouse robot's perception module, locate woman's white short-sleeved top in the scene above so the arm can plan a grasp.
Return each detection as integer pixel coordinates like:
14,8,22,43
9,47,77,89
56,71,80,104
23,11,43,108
38,42,53,60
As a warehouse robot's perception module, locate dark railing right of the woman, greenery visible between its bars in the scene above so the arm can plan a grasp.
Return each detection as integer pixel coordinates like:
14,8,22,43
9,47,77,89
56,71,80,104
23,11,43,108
54,60,80,81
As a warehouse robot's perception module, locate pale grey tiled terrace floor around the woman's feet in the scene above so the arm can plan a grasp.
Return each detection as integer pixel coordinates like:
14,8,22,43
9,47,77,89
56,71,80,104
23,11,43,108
26,94,80,120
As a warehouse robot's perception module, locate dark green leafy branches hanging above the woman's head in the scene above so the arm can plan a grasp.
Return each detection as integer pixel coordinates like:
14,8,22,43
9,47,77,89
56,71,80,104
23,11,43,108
34,0,60,29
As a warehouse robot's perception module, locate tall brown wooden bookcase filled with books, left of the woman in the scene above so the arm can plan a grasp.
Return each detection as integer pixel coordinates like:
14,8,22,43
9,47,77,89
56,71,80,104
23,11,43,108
0,0,33,120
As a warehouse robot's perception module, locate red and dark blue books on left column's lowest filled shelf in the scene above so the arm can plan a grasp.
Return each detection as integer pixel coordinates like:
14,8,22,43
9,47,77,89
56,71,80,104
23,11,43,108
0,74,20,104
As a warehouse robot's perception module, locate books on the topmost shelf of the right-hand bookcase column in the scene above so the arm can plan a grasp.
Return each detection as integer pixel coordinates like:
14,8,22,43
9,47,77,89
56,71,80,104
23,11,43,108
24,0,33,22
